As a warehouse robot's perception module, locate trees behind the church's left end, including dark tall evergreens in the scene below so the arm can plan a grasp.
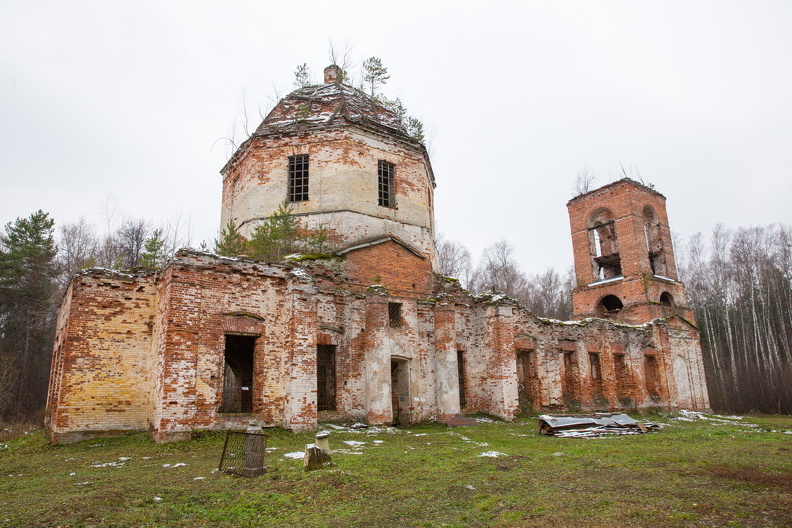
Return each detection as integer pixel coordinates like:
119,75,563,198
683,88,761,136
0,206,190,421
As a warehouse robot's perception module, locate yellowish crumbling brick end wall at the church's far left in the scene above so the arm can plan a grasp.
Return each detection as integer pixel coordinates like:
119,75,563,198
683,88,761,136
46,271,155,441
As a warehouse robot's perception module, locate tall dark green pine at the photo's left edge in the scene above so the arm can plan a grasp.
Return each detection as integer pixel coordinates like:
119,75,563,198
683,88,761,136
0,211,58,417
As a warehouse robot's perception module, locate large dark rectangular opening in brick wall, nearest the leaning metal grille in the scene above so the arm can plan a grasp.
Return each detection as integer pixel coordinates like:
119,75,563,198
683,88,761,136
220,335,256,413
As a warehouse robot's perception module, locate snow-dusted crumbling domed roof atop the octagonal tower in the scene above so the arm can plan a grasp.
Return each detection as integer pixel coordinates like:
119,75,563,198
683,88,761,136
254,70,409,138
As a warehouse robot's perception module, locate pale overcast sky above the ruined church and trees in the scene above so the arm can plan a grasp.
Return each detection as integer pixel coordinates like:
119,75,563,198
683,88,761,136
0,0,792,273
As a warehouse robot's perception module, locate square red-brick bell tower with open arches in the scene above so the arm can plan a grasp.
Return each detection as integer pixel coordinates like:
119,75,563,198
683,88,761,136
567,178,695,324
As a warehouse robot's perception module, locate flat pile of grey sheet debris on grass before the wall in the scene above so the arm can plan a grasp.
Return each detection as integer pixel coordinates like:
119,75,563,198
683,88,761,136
539,413,662,438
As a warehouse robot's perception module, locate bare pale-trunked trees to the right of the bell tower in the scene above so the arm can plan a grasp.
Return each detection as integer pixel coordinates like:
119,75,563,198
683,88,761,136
679,225,792,414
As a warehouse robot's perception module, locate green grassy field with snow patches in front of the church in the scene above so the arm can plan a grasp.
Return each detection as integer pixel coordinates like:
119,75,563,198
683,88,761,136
0,416,792,528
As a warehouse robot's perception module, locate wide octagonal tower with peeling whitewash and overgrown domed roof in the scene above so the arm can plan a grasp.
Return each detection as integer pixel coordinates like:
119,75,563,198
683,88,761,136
221,65,437,268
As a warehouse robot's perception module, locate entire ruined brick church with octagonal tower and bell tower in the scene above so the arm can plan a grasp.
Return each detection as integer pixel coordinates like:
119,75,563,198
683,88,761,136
46,66,709,442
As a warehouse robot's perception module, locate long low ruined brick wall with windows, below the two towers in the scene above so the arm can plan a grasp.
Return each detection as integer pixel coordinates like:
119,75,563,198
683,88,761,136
47,246,708,441
